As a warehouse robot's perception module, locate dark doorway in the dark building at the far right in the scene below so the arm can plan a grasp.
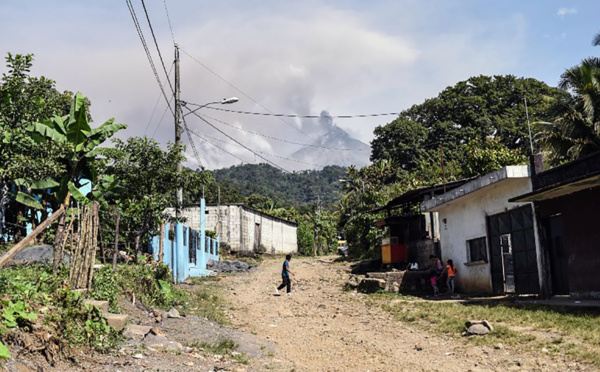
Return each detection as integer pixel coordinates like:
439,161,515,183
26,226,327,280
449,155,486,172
544,214,569,295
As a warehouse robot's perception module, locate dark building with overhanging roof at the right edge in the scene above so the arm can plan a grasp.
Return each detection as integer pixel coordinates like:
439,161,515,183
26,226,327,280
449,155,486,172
511,153,600,298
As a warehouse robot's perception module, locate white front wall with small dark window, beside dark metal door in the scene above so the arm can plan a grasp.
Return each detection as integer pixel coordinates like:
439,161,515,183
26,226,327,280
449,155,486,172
438,178,539,293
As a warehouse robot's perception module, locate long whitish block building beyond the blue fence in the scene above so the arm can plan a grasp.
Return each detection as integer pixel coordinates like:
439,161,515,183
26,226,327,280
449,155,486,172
172,204,298,254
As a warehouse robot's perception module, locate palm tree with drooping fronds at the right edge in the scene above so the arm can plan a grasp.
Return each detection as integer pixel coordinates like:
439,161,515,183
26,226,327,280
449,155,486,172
538,57,600,163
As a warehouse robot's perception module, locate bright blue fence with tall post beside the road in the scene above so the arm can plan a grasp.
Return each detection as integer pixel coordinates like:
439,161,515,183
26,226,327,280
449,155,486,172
149,199,219,283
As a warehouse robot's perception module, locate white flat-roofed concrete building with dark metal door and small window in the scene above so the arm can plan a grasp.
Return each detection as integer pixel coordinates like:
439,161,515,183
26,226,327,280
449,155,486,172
421,165,541,294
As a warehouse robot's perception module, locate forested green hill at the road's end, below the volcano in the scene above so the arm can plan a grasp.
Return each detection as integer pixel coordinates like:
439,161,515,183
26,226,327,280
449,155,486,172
213,164,346,206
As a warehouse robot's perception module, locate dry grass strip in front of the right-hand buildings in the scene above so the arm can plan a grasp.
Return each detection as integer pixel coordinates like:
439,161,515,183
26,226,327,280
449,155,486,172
367,294,600,366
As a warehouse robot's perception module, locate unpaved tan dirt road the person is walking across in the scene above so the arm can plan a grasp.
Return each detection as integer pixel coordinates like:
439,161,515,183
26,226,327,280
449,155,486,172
223,258,590,372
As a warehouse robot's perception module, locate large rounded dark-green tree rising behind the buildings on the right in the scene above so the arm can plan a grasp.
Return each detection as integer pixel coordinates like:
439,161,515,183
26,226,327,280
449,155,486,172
371,75,560,171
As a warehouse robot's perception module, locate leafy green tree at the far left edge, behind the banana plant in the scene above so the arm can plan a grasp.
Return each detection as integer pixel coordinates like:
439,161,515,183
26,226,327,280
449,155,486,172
0,53,89,239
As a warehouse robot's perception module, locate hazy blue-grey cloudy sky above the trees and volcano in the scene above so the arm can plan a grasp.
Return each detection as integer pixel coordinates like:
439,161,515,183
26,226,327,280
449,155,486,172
0,0,600,169
